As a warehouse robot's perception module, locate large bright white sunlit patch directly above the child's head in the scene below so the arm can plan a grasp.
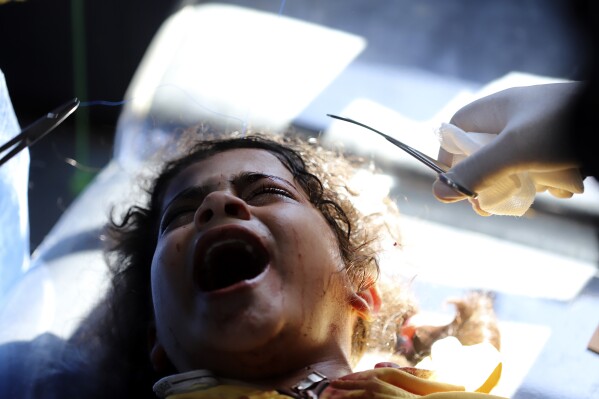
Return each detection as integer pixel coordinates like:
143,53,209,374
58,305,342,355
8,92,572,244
115,3,366,170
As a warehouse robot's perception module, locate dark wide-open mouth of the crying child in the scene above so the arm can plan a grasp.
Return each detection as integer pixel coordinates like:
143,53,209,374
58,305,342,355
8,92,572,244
195,237,269,292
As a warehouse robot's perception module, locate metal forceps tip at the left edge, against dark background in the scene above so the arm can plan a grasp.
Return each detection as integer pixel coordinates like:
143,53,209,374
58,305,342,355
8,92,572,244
0,98,79,166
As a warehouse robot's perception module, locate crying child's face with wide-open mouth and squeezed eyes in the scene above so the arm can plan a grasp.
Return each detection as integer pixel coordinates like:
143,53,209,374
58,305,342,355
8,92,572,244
151,149,355,377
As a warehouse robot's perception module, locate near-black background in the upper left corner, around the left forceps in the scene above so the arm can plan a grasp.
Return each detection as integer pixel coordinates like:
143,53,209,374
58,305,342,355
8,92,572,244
0,0,176,250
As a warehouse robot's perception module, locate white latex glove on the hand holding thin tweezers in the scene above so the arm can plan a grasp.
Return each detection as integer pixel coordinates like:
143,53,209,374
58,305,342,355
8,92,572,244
433,82,584,216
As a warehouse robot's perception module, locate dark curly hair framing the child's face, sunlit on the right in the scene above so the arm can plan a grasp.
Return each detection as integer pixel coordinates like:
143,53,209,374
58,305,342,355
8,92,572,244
77,129,396,397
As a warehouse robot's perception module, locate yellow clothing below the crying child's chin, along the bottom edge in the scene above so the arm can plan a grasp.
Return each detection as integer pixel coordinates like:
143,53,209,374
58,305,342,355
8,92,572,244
168,367,506,399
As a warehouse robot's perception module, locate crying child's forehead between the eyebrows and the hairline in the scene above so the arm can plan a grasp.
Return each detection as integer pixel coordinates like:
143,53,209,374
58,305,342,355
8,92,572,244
163,148,293,204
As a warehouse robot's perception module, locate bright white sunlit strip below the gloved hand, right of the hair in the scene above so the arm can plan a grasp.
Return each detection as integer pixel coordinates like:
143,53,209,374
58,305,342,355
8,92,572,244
383,216,597,301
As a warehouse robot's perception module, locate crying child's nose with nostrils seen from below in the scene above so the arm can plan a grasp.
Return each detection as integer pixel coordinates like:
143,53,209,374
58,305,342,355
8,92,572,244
194,191,251,227
